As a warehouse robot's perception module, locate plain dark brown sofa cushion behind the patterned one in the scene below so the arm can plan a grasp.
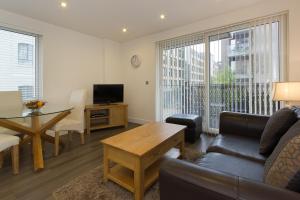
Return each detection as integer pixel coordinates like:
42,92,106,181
259,108,297,155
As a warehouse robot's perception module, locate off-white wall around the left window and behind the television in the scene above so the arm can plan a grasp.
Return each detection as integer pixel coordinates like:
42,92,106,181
0,10,121,103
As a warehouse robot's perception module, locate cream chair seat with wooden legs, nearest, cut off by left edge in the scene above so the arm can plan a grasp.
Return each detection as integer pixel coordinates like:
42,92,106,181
0,134,20,174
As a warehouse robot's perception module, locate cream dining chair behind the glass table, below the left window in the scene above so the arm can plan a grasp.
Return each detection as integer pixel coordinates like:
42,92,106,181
0,91,28,135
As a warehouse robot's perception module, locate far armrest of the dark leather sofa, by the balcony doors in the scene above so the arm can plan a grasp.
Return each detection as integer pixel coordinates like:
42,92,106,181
219,112,270,138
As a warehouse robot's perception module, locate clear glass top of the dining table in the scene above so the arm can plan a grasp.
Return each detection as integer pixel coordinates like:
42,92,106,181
0,103,73,119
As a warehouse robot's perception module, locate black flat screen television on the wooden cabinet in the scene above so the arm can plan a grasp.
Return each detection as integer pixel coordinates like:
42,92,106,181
93,84,124,104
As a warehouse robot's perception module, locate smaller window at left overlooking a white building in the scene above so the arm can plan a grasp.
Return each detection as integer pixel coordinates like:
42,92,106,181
0,28,41,101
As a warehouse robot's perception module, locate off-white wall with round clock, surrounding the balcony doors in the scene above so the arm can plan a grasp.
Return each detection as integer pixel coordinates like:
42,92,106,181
121,0,300,122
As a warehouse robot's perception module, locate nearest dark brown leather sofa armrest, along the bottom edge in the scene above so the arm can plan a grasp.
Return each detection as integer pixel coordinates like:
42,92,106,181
159,159,300,200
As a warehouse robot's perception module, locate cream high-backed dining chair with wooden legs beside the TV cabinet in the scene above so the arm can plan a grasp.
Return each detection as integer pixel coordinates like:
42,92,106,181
46,89,87,156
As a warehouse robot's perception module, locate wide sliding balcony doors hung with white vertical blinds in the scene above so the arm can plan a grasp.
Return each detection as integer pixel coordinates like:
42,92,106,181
157,14,286,132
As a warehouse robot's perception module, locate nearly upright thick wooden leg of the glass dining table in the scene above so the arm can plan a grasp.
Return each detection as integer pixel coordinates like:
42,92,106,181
31,116,44,171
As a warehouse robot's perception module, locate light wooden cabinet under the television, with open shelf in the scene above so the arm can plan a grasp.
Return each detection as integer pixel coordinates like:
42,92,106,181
85,104,128,135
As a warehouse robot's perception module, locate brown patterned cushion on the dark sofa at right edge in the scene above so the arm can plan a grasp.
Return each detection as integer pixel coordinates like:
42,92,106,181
264,121,300,192
